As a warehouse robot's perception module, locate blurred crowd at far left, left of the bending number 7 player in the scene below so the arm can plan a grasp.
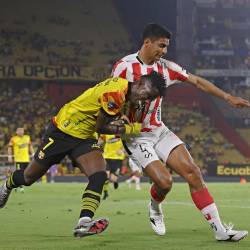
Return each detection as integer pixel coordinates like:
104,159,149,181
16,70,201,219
0,81,55,154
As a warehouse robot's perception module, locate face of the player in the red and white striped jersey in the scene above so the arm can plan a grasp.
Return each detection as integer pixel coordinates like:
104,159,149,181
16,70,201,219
147,38,169,61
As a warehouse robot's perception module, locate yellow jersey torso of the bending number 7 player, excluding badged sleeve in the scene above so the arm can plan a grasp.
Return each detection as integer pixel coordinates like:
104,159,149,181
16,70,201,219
55,79,127,139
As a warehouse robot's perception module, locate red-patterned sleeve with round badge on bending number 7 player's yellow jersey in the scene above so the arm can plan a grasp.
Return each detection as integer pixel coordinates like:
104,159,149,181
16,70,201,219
101,91,125,115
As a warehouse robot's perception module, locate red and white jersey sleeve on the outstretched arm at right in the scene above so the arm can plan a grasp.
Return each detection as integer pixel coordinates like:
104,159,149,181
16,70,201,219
165,61,188,86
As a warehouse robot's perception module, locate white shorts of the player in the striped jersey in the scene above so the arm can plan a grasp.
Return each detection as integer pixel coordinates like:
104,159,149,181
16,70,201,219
124,127,184,168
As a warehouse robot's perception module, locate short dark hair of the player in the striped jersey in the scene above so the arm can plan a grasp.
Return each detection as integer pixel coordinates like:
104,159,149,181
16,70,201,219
142,23,172,41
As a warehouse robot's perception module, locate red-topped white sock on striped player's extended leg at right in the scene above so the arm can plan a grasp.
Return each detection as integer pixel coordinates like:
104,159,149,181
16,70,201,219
191,188,225,233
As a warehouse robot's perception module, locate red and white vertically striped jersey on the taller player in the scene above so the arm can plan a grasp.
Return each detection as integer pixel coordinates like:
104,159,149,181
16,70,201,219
112,52,188,132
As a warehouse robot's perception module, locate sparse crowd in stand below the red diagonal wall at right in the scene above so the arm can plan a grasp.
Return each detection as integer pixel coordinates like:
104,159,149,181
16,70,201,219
162,103,248,172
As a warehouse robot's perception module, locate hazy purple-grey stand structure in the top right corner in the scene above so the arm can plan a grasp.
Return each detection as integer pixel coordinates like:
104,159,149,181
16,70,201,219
194,0,250,69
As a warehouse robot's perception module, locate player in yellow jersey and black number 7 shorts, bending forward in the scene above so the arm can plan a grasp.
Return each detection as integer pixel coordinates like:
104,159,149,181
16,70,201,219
0,72,166,237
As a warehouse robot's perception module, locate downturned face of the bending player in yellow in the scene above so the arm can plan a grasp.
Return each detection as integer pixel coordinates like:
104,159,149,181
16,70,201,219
130,78,159,103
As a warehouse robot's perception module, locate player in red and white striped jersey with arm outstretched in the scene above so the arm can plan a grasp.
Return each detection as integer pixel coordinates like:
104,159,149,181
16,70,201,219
112,24,250,241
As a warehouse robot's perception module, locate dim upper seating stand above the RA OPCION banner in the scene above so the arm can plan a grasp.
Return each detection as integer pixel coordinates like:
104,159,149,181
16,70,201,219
0,0,131,76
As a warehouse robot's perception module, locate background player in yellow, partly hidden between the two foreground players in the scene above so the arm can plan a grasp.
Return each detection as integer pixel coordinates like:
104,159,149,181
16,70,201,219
100,135,125,200
